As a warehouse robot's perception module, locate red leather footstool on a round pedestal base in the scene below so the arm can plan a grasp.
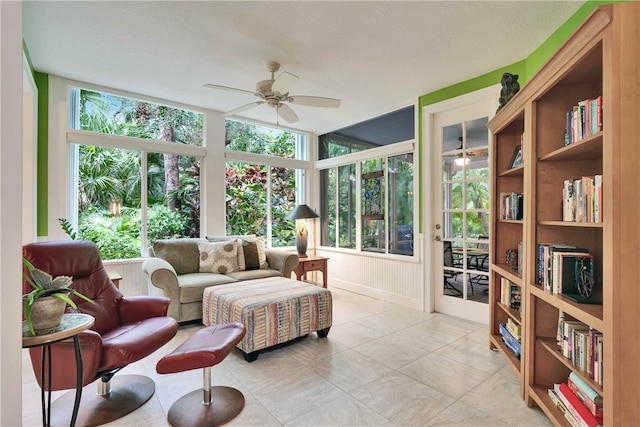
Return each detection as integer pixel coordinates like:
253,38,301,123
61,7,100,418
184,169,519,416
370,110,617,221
156,323,245,427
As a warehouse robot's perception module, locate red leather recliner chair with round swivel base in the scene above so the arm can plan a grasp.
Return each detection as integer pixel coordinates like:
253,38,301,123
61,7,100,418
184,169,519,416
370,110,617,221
22,240,178,425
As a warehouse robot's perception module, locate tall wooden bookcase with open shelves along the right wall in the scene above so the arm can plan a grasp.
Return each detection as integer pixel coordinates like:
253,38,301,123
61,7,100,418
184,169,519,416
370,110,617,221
488,2,640,425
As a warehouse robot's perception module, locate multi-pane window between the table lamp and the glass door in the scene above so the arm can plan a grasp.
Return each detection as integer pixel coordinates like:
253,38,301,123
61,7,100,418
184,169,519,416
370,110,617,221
320,143,414,256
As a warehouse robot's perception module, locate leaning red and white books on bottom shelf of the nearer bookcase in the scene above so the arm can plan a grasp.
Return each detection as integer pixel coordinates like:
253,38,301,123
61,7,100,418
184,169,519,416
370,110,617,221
549,372,604,427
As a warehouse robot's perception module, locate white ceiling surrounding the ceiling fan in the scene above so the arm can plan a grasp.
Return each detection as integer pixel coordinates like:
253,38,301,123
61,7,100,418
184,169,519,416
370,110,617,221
23,0,584,133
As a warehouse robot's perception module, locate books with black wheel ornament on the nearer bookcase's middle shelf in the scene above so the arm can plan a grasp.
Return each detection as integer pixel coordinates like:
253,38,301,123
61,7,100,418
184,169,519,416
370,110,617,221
536,243,599,303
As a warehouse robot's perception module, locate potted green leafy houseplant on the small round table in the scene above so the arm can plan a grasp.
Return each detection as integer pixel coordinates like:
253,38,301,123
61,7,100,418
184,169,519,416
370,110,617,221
22,258,94,335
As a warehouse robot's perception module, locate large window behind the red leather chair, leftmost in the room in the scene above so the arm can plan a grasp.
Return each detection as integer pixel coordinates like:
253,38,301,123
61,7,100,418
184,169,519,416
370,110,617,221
68,88,204,259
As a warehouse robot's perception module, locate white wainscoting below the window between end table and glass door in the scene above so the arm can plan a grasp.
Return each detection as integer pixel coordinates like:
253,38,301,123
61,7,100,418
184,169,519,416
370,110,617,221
316,249,424,310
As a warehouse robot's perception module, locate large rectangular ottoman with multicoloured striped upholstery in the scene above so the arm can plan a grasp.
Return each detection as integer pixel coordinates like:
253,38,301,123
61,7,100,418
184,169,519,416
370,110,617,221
202,277,332,362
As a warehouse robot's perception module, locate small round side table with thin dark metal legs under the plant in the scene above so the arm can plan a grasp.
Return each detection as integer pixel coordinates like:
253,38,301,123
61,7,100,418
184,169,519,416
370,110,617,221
22,313,95,426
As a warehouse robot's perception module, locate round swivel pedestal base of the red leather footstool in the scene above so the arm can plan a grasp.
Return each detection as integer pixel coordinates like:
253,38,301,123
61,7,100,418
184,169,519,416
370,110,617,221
168,367,244,427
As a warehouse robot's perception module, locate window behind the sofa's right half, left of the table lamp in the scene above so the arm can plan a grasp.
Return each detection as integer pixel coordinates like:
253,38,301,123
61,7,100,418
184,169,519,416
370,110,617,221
225,120,308,247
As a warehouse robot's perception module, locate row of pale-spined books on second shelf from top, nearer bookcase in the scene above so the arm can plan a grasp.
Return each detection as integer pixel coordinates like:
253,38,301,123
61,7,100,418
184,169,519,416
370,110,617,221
562,175,602,222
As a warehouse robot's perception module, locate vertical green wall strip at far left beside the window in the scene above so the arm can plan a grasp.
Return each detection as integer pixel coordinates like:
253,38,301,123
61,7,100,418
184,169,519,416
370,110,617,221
33,71,49,236
